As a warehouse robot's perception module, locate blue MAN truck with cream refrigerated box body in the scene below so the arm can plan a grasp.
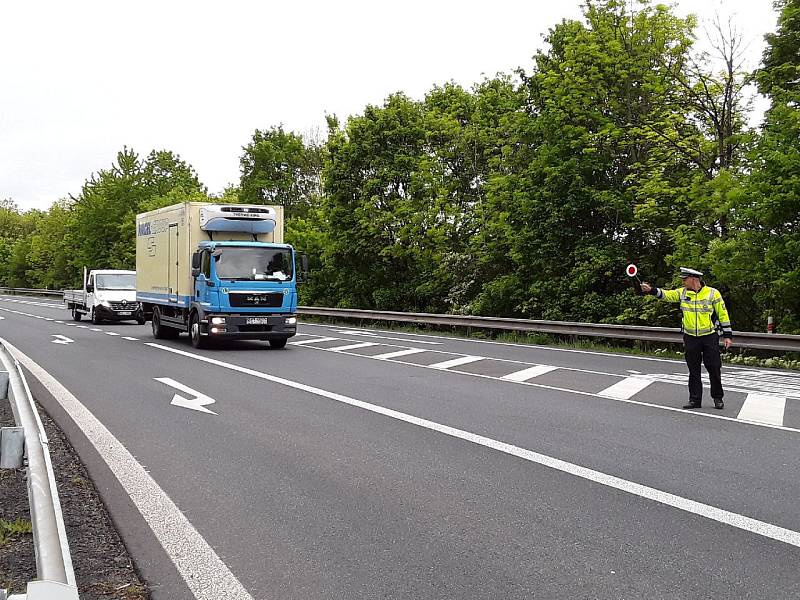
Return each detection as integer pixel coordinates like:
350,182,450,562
136,202,306,348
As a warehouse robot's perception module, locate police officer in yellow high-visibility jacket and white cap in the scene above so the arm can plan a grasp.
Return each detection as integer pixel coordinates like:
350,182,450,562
642,267,733,409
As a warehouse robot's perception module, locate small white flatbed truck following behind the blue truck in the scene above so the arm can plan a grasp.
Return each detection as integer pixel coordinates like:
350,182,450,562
64,269,145,325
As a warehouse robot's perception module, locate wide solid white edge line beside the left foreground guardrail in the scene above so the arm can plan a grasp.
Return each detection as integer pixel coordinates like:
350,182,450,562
3,341,253,600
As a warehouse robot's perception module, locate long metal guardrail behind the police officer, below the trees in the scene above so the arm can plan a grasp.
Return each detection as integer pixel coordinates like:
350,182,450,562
297,306,800,352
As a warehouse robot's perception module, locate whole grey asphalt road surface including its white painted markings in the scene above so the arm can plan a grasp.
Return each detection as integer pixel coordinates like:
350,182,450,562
0,296,800,600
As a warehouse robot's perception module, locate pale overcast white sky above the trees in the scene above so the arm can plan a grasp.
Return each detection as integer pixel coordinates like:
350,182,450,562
0,0,777,210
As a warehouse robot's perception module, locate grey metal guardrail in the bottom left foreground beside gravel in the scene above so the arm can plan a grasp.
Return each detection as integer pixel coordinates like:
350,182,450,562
0,338,78,600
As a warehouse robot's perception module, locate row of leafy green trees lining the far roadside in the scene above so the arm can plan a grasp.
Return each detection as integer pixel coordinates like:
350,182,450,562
0,0,800,333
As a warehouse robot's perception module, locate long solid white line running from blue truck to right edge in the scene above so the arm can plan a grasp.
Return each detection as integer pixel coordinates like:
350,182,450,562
147,342,800,548
